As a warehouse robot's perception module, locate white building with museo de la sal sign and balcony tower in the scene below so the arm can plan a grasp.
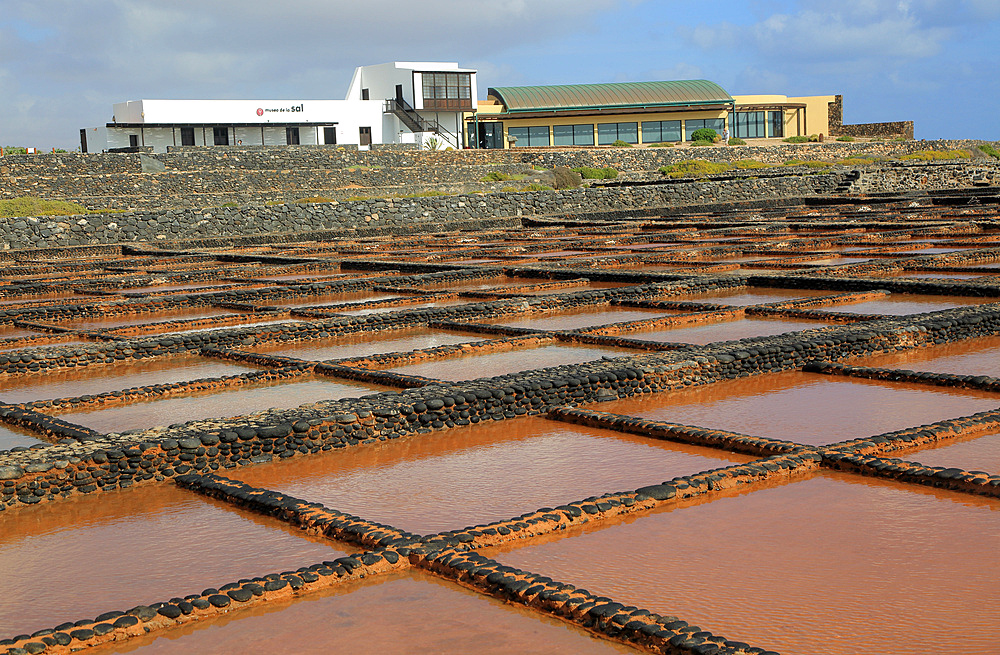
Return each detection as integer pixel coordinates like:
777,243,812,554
80,62,477,152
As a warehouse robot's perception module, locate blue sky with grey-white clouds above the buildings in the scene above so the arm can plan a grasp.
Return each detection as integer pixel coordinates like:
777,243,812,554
0,0,1000,150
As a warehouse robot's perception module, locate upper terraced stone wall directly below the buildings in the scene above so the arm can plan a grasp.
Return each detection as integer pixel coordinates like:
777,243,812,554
0,141,978,210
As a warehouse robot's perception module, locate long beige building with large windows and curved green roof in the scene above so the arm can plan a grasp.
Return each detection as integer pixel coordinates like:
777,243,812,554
465,80,835,148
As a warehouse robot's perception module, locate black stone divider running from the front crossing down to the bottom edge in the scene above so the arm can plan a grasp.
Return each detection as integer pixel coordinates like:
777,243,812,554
418,550,777,655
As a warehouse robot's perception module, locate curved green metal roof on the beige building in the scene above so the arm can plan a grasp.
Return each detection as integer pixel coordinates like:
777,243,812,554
489,80,733,113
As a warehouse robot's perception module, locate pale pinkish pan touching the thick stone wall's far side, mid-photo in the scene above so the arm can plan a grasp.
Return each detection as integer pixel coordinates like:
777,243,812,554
392,345,635,380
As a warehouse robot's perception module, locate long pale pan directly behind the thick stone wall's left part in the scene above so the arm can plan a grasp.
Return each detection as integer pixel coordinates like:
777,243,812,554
50,378,387,432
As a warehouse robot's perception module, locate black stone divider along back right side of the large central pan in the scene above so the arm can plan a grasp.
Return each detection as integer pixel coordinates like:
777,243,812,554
547,407,803,457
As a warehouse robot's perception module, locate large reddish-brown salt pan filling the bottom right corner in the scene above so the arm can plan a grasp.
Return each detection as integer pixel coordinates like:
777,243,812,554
490,474,1000,655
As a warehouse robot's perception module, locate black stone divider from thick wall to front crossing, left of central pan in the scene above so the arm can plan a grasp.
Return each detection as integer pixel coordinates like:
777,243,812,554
174,473,420,554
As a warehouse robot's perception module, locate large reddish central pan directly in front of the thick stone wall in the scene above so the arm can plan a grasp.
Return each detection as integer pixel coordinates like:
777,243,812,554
230,417,750,533
